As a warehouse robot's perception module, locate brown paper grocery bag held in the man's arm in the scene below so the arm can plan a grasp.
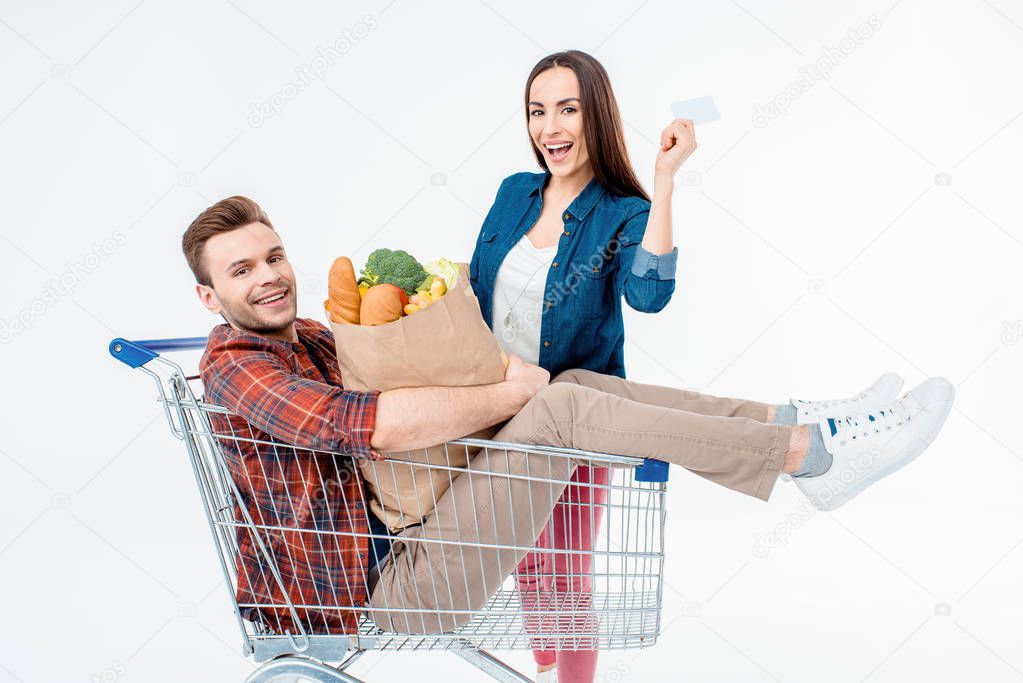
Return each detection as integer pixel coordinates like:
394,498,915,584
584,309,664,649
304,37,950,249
327,258,504,531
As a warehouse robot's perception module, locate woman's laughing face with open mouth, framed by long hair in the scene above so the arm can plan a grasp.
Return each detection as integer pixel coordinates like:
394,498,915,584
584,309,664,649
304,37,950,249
528,66,589,176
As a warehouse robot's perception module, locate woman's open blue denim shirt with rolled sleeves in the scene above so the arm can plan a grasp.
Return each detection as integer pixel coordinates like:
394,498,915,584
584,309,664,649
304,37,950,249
470,173,678,377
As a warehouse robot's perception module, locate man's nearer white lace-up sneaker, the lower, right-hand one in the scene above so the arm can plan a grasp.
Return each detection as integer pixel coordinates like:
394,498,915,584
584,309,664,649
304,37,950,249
792,377,955,510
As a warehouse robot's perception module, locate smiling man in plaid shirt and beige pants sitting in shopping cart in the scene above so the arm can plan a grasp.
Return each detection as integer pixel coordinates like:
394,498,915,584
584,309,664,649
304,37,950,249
183,197,953,633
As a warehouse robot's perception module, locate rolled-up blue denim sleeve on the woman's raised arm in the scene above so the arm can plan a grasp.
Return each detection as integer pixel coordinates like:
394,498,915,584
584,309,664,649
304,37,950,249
618,202,678,313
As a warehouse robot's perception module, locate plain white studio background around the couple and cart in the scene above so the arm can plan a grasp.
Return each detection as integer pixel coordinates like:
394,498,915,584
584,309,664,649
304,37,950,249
0,0,1023,683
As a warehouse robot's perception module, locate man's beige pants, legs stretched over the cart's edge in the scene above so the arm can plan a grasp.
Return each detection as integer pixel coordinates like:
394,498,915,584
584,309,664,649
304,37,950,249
369,370,791,633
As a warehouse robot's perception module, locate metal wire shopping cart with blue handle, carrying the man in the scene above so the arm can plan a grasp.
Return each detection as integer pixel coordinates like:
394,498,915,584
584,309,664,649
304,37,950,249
109,337,667,683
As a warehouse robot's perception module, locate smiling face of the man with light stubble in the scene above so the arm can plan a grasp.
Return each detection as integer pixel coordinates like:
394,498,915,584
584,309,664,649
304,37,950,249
195,223,298,342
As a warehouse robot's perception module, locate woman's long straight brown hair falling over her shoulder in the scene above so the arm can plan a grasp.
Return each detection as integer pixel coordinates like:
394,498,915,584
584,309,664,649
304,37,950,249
526,50,650,201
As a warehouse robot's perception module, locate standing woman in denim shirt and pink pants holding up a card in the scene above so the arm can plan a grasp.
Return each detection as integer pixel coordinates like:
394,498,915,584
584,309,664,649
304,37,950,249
470,50,697,683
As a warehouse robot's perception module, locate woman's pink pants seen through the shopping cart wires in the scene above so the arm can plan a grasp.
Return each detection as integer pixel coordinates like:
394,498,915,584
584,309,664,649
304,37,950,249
516,467,610,683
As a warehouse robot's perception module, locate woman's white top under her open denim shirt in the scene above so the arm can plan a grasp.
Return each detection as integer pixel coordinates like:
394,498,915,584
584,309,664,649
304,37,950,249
493,235,558,365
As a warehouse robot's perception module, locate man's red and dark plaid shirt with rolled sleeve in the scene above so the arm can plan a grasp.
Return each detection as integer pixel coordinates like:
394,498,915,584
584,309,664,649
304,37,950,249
199,318,381,633
